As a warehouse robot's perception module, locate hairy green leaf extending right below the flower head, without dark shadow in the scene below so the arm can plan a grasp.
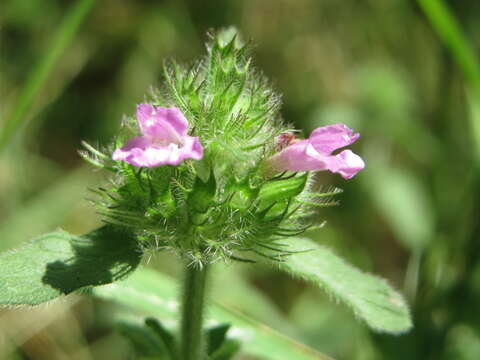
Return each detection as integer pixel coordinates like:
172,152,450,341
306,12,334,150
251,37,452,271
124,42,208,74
263,238,412,334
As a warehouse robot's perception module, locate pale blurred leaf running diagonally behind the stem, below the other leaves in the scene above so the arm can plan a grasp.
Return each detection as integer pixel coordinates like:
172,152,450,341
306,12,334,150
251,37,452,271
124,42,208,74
92,268,331,360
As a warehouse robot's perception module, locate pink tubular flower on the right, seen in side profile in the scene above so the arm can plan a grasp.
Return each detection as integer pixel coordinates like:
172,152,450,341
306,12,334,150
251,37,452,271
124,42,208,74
268,124,365,179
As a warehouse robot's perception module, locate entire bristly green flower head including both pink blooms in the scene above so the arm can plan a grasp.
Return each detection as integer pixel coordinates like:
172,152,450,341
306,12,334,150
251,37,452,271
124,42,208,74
83,31,364,265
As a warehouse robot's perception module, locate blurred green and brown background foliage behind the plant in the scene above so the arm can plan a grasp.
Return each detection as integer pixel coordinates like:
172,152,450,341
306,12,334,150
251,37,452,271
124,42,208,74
0,0,480,360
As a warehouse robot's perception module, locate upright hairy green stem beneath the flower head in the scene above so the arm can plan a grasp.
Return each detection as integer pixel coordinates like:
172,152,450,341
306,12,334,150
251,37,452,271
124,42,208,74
180,266,208,360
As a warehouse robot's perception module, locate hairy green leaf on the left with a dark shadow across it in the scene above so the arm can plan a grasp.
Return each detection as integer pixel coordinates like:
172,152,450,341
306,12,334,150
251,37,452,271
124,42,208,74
0,226,141,305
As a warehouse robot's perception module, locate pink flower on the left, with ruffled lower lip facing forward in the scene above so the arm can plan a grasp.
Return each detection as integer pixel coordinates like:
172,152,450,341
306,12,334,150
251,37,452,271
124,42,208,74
112,104,203,167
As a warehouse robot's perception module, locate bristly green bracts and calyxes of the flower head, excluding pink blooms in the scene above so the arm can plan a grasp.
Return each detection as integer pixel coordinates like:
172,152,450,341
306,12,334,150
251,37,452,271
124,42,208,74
81,31,334,265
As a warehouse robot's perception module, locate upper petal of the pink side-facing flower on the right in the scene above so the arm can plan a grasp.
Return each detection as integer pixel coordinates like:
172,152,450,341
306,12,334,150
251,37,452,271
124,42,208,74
309,124,360,155
